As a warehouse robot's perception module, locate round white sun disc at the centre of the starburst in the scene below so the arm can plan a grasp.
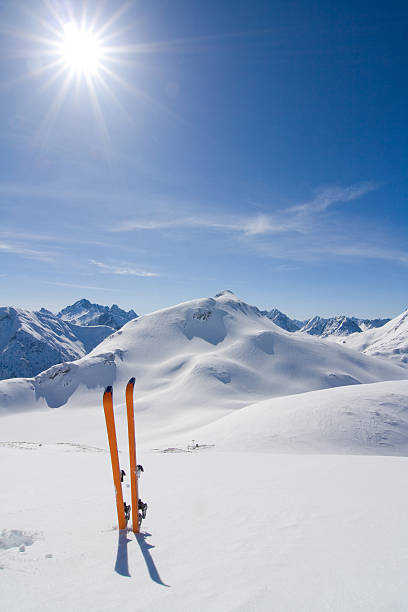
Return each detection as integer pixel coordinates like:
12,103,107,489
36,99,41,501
59,23,104,77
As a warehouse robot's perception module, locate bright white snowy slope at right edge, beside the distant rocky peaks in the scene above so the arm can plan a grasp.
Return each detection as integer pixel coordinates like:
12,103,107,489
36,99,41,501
342,310,408,365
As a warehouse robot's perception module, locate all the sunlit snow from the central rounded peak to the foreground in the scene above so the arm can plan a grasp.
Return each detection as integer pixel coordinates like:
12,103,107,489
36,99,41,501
0,295,408,612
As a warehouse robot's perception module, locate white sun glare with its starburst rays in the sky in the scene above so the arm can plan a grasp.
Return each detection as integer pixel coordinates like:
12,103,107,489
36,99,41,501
13,0,151,147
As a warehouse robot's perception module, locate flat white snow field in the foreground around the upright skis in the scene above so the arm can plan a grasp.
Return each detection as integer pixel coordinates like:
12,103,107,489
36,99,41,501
0,444,408,612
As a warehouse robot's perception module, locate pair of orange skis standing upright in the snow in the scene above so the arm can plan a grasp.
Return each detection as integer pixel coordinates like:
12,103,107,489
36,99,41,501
103,378,140,533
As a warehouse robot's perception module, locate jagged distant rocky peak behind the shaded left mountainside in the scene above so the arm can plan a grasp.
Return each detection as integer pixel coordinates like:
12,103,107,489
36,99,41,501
57,299,137,329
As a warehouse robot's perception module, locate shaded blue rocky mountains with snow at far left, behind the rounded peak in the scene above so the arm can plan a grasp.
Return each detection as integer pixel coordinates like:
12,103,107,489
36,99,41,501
0,300,137,380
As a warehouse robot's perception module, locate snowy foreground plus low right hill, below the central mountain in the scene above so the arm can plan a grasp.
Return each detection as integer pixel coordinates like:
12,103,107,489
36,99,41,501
0,381,408,612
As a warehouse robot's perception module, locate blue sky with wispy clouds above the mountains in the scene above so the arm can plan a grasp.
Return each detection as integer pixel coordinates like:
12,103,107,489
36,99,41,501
0,0,408,318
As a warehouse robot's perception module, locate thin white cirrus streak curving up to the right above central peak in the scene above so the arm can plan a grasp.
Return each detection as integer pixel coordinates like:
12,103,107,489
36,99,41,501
109,182,379,236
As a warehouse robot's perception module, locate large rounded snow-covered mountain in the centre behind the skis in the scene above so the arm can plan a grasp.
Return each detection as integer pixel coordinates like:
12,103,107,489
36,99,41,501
0,292,408,420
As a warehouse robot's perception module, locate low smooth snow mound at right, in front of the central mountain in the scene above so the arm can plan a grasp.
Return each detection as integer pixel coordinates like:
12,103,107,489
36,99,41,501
194,380,408,456
